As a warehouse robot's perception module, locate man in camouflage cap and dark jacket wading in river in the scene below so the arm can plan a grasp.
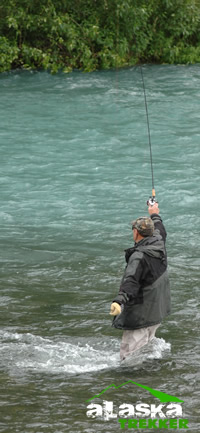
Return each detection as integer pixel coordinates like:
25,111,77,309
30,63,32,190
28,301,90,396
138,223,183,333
110,203,170,360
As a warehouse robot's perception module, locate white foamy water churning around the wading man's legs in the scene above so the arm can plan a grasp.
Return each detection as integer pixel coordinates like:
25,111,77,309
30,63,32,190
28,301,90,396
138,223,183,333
0,331,171,374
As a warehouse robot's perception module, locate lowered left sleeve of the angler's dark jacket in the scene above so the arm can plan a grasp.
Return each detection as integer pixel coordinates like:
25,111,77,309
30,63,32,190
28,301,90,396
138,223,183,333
113,251,143,305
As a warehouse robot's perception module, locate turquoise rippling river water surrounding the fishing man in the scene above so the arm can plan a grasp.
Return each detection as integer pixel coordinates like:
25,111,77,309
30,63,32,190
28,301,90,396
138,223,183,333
0,65,200,433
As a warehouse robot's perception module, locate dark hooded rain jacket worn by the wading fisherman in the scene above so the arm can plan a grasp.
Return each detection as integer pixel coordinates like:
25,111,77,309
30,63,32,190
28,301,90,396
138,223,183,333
113,214,170,330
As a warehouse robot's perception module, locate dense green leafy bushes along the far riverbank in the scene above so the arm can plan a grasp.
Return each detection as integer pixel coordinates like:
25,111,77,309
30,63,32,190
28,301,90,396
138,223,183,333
0,0,200,73
